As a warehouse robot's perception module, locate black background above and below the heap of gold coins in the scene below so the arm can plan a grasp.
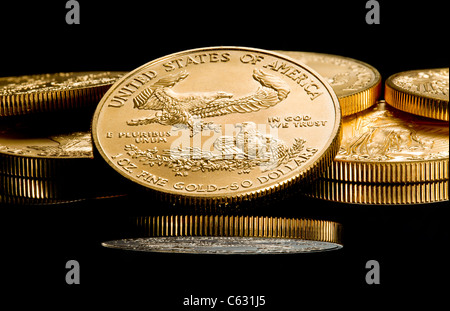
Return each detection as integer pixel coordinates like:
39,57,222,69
0,0,450,310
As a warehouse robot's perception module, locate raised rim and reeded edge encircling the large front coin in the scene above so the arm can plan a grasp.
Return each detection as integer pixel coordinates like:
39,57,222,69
91,46,342,207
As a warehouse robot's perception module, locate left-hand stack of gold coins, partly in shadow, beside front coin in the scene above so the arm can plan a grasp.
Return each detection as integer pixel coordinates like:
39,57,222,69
0,72,124,204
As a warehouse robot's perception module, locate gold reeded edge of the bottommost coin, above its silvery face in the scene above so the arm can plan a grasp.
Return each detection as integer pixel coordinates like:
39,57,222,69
136,215,342,244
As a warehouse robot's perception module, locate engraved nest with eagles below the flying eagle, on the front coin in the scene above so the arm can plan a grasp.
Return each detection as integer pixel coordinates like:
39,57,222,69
124,121,306,176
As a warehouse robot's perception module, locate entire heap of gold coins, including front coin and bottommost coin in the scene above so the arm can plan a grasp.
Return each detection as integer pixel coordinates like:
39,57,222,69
0,47,448,253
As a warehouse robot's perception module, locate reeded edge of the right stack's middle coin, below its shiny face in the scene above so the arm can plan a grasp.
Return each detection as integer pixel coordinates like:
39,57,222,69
321,158,449,183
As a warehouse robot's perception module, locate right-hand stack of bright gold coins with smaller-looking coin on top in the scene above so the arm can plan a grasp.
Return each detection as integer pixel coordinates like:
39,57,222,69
308,68,449,204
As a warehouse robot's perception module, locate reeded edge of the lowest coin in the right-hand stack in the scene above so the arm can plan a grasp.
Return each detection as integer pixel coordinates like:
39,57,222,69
304,179,449,205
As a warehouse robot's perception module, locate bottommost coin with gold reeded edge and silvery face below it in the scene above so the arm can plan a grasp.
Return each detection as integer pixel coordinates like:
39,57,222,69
102,215,342,254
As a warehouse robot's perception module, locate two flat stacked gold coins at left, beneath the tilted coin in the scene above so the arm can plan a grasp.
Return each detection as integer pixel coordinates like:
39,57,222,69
0,123,124,204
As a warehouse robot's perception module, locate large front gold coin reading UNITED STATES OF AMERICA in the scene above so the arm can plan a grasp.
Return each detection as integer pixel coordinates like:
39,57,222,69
92,47,341,204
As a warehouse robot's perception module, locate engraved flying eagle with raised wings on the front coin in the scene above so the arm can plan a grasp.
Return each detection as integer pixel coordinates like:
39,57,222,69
127,69,290,131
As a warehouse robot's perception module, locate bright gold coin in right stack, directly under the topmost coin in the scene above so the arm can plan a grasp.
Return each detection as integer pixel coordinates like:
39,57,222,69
322,101,449,183
